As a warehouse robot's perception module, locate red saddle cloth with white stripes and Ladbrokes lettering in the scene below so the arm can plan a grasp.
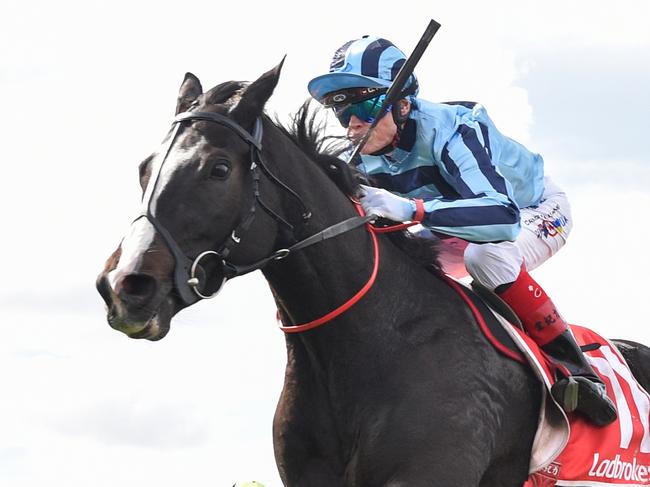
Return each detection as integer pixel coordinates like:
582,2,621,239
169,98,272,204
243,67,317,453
523,325,650,487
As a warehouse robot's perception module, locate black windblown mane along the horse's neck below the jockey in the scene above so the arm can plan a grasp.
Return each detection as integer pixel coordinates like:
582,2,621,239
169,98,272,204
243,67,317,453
275,100,443,274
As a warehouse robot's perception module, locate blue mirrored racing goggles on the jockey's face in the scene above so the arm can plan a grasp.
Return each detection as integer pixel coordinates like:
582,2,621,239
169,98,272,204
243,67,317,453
322,88,390,128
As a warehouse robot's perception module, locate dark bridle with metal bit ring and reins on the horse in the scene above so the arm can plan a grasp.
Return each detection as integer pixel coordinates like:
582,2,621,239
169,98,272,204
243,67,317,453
134,112,378,306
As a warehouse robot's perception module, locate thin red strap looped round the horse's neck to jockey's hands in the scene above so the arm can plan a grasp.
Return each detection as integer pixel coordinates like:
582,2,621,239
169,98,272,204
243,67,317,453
280,200,424,333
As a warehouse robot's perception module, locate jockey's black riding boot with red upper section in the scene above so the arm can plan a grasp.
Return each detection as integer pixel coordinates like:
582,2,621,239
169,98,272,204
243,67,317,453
495,267,616,426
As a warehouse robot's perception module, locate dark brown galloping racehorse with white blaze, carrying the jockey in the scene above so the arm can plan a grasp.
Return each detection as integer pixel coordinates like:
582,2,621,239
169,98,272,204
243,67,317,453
97,63,650,487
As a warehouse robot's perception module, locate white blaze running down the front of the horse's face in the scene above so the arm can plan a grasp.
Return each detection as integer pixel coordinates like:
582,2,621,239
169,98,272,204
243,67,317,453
108,130,204,292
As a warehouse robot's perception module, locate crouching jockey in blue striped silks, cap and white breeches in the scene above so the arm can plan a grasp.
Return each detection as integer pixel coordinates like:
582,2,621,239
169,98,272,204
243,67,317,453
308,36,616,425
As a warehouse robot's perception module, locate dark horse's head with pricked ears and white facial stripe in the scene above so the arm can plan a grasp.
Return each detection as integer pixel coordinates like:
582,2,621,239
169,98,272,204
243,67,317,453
97,63,282,340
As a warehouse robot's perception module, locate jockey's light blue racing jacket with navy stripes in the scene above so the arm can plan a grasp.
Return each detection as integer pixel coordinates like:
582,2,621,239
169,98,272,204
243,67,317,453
358,99,544,242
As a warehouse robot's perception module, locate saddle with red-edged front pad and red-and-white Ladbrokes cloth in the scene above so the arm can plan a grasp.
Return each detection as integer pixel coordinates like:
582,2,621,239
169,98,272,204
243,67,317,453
450,281,650,487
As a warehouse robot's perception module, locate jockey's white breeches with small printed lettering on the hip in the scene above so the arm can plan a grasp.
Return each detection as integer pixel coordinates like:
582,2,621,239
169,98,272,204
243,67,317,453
460,178,573,290
